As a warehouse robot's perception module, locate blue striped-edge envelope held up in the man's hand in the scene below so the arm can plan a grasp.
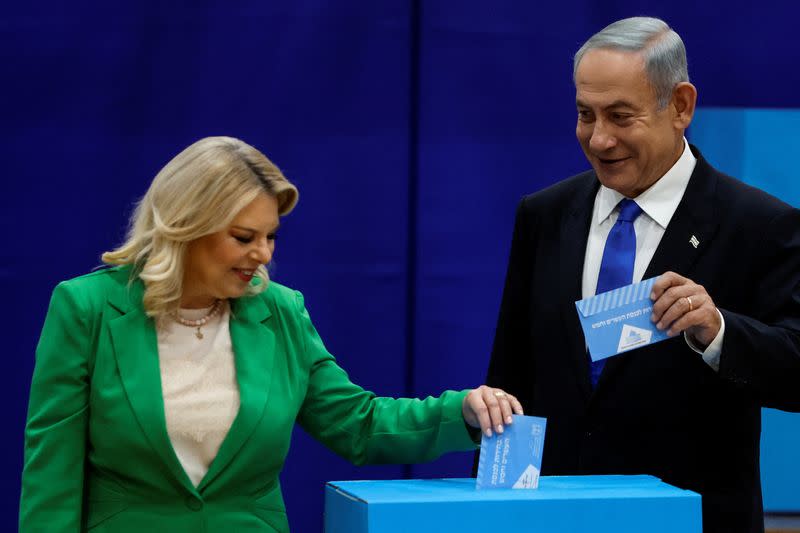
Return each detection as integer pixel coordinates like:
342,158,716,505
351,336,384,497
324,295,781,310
575,278,669,361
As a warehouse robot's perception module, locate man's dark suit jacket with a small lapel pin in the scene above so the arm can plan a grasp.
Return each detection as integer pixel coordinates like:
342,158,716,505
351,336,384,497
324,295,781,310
487,148,800,533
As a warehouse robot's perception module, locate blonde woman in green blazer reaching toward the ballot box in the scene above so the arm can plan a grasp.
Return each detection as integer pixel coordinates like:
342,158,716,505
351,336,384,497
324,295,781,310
20,137,522,533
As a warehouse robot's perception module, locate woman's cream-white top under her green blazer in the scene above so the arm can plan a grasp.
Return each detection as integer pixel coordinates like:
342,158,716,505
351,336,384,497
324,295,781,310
158,302,239,486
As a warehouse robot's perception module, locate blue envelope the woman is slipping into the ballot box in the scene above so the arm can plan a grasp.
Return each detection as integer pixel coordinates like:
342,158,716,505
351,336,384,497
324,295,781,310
475,415,547,489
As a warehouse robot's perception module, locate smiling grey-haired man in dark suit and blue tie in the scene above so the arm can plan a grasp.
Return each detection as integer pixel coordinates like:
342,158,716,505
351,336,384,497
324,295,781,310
487,17,800,533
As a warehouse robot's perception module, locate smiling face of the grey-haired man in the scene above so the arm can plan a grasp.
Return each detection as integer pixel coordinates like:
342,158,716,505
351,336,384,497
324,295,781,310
575,49,683,198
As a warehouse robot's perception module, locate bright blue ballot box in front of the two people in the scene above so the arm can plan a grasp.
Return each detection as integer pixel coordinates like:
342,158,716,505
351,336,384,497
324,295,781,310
325,476,702,533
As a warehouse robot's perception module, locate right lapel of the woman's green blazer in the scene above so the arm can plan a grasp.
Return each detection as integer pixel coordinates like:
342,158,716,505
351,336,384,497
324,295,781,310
197,296,275,491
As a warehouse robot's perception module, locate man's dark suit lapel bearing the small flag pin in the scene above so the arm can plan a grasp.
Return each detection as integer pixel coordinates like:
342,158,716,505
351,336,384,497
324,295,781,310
596,146,717,390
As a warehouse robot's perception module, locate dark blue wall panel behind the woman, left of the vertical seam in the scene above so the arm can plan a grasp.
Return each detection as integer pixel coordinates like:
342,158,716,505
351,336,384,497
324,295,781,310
6,0,410,531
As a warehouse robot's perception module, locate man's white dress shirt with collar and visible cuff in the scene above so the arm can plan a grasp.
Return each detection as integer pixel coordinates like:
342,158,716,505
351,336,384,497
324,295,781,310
582,138,725,371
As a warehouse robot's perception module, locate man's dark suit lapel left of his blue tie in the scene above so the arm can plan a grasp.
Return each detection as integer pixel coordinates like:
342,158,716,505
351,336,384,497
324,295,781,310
554,173,599,401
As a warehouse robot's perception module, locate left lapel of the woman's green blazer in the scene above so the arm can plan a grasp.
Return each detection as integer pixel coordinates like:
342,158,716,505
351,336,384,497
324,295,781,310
108,281,195,492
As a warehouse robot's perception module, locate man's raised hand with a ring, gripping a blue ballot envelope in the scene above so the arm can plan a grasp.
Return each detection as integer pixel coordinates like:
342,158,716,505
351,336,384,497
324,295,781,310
650,272,722,348
